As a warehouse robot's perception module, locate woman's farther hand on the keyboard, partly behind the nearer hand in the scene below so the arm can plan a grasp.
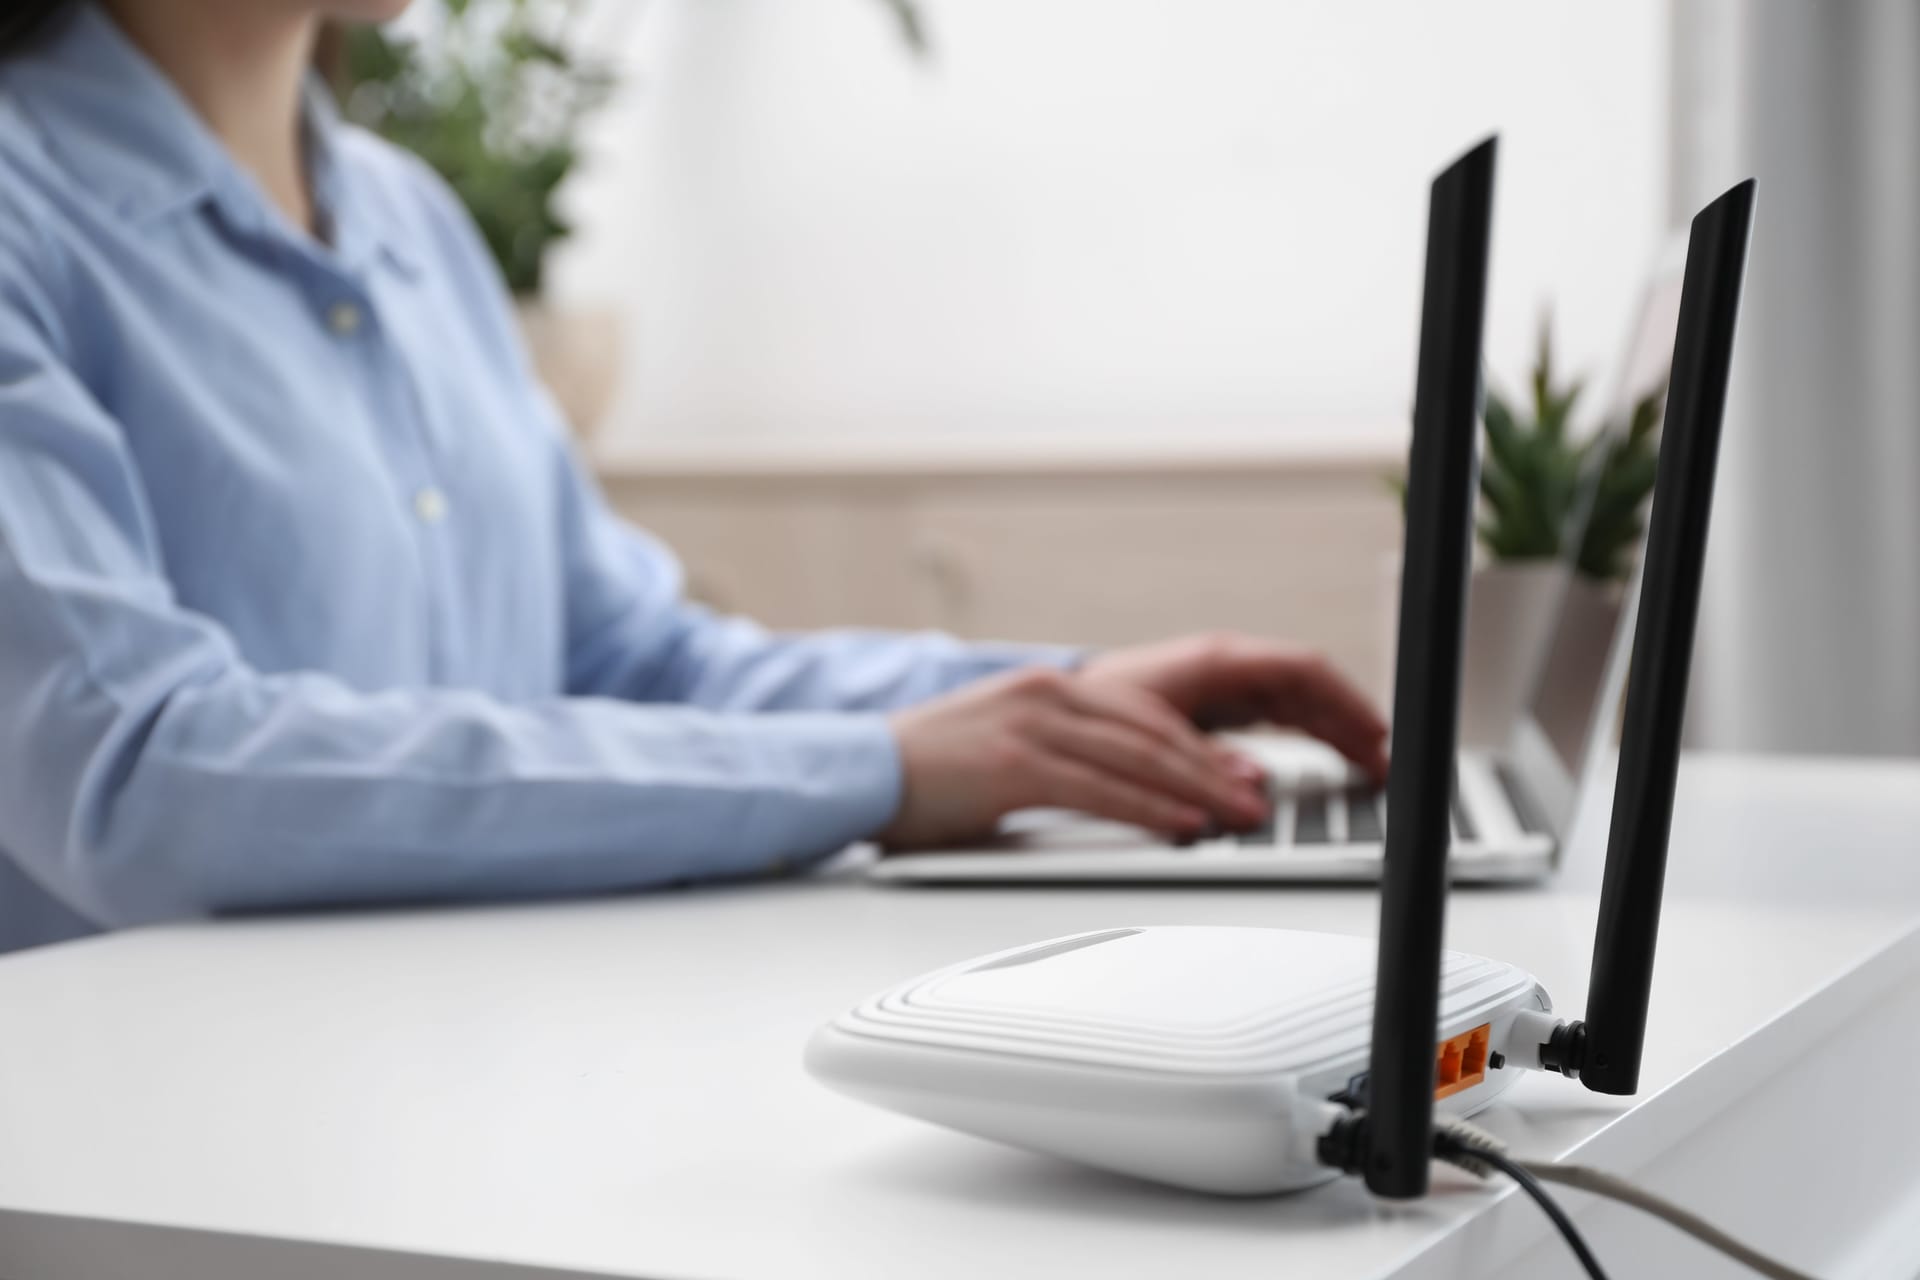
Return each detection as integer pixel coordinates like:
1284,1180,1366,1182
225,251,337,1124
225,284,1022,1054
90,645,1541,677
1083,631,1386,783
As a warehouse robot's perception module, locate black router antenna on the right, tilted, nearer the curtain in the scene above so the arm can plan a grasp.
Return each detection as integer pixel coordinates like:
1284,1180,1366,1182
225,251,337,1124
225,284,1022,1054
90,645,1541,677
1572,178,1753,1094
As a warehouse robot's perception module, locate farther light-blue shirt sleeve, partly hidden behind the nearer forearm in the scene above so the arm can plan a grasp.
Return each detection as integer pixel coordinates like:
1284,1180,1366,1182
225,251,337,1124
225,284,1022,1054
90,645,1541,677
559,447,1083,712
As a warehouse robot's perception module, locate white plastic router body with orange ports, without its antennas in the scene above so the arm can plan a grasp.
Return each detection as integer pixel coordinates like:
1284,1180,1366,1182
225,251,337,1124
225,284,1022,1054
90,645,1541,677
806,927,1551,1196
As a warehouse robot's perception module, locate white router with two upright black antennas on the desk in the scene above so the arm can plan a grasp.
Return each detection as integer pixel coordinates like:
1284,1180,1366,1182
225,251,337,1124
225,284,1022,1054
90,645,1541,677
806,138,1753,1197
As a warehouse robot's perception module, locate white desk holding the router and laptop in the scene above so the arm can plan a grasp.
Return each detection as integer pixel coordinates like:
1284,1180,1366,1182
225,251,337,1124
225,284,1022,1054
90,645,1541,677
0,760,1920,1280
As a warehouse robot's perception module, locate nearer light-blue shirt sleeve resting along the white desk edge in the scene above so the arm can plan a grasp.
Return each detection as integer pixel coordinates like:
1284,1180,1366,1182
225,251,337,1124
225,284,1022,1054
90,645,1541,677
0,274,899,925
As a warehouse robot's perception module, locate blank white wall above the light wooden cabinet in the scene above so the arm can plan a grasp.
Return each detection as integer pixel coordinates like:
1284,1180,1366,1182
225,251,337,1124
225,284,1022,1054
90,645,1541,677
555,0,1667,449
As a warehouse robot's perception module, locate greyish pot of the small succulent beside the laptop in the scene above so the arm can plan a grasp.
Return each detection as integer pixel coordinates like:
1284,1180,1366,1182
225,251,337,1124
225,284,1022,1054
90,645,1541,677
1382,557,1571,750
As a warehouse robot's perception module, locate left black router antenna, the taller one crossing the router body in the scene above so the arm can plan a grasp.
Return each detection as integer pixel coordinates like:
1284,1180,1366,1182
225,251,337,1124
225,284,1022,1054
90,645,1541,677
1365,138,1498,1197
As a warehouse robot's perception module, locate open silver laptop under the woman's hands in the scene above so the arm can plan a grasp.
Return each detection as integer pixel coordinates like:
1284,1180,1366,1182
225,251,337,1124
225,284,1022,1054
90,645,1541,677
868,238,1686,885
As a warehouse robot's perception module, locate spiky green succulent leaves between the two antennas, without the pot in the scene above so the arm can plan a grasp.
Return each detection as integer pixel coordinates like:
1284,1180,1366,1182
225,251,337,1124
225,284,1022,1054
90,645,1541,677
1392,320,1667,581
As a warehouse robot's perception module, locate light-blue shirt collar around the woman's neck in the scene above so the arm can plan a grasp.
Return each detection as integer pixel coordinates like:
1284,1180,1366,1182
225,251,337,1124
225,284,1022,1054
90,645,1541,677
8,2,415,271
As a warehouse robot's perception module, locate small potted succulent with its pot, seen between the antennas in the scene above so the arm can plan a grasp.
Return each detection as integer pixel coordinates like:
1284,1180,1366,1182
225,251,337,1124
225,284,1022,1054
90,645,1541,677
1390,320,1667,747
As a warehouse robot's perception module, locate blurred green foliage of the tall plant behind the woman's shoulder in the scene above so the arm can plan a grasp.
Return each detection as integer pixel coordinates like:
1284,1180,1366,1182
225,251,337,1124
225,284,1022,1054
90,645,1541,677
349,0,927,296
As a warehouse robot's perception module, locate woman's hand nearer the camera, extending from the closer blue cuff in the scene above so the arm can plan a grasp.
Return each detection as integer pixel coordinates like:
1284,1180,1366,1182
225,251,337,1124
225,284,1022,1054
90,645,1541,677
876,668,1267,850
